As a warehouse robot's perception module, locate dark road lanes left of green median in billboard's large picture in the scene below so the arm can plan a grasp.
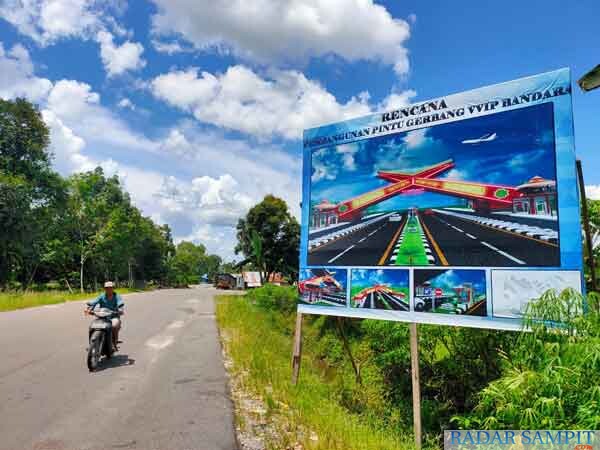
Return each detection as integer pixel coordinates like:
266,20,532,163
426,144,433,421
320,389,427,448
308,218,404,266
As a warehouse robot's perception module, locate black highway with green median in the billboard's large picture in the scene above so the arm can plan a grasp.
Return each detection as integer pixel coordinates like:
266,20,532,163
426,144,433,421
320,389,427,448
308,209,559,267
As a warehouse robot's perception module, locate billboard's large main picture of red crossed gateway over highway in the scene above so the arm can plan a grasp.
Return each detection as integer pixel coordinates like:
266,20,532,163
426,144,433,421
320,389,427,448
307,103,560,267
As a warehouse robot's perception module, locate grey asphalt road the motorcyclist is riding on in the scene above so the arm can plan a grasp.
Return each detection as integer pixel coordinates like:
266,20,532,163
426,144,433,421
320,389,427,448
0,287,237,450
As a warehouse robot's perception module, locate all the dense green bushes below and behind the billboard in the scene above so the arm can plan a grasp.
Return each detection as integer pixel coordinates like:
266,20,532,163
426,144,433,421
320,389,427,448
233,285,600,445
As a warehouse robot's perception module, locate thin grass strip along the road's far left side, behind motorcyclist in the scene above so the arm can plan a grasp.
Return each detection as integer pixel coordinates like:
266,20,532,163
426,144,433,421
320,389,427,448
0,288,142,312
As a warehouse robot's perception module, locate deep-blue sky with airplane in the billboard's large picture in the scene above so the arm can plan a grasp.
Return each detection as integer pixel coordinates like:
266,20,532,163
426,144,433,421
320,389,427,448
311,103,556,211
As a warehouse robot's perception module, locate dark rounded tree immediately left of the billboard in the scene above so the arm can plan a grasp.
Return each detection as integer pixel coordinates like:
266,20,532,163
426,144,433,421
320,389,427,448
235,195,300,280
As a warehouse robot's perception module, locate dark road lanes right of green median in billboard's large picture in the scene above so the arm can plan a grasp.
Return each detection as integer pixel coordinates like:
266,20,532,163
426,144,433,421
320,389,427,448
420,214,560,267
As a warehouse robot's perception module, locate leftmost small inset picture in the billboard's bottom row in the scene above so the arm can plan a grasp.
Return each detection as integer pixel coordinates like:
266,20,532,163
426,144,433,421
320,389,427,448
298,267,348,306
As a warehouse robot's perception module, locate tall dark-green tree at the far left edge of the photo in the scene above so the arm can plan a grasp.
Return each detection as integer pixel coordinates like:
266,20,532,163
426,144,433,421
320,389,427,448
0,99,66,283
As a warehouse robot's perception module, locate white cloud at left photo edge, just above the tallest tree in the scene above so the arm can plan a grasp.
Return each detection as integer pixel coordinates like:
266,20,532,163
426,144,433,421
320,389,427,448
0,42,52,102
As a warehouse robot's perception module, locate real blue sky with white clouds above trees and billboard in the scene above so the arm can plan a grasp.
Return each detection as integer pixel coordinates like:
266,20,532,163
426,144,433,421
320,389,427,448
0,0,600,259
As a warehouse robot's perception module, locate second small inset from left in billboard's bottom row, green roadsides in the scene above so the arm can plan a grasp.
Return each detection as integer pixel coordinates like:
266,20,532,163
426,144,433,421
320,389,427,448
350,269,410,311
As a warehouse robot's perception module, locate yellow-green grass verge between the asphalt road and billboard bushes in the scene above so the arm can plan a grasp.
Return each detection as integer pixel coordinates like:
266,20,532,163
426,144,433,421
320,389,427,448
216,296,414,450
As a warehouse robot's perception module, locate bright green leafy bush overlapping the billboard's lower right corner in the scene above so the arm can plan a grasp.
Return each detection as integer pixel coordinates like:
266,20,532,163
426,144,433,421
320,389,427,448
454,290,600,429
